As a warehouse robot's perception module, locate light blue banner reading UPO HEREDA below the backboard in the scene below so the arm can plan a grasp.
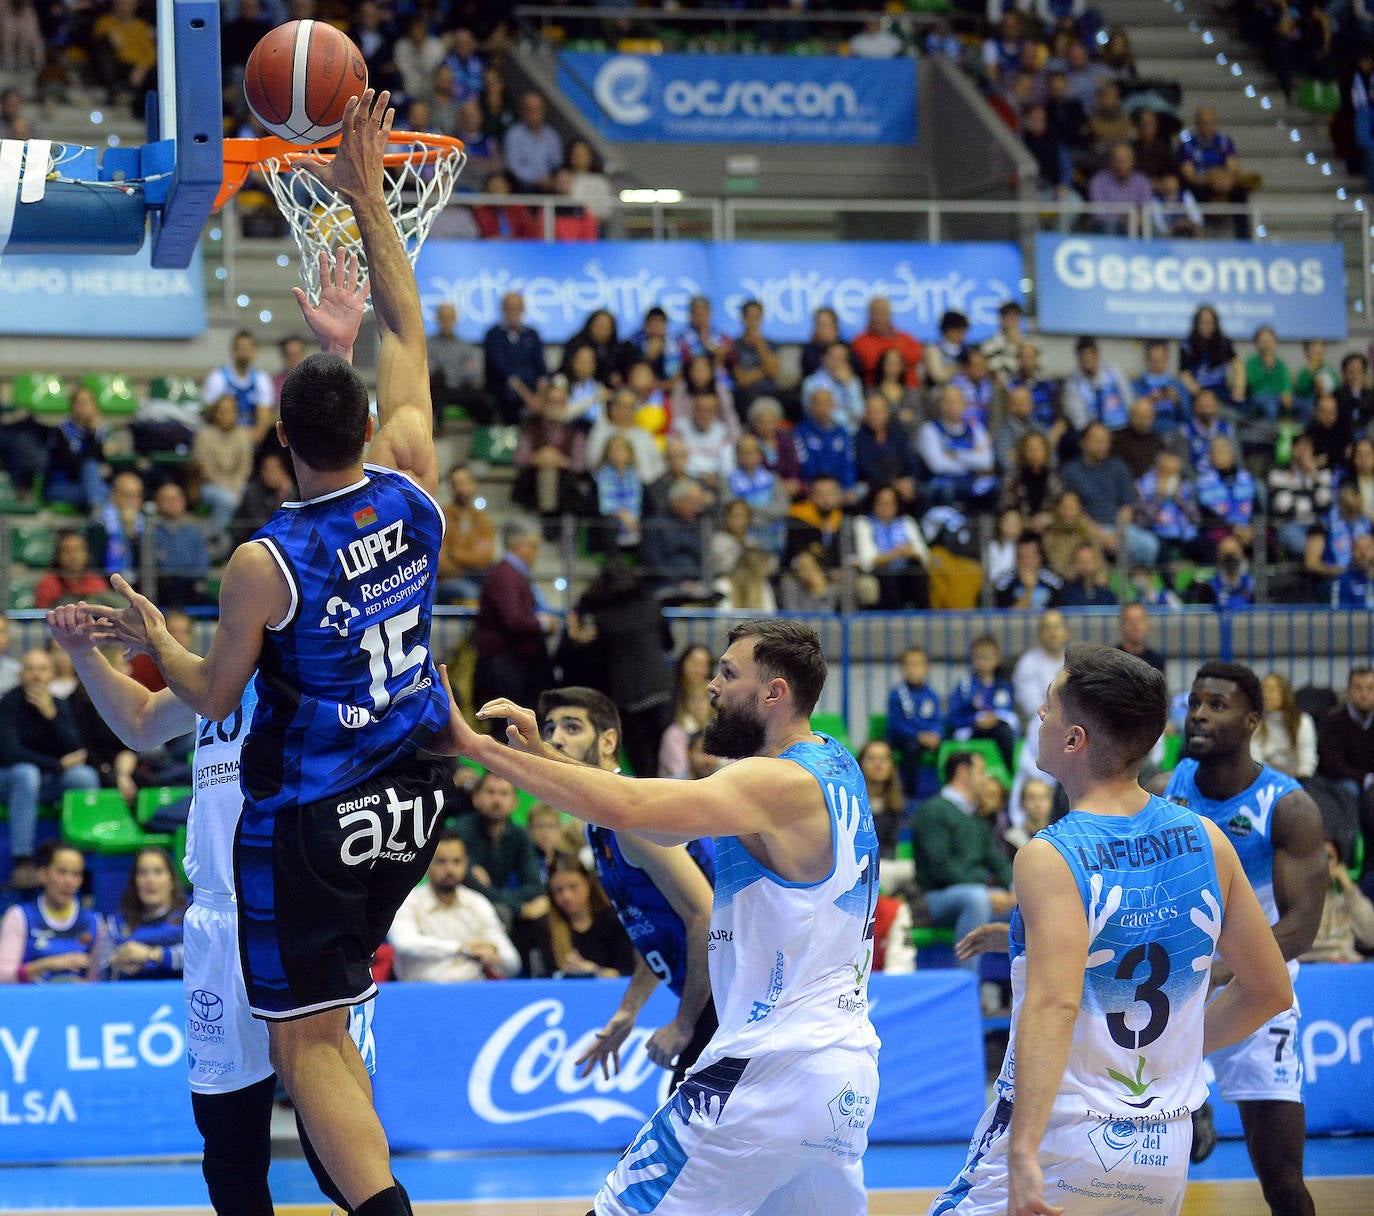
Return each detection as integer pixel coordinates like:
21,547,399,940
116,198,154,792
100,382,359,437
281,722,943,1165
0,242,206,338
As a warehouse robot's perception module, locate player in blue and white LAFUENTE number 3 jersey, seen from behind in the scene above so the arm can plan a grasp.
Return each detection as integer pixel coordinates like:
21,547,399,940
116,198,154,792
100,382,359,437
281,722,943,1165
930,646,1293,1216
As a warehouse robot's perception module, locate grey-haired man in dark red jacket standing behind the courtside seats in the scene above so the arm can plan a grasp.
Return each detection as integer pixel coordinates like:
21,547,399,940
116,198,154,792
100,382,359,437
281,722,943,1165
473,515,554,705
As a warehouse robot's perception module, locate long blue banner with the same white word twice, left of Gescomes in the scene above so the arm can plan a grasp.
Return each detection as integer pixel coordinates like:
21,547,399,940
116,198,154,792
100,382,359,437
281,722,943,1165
415,240,1022,342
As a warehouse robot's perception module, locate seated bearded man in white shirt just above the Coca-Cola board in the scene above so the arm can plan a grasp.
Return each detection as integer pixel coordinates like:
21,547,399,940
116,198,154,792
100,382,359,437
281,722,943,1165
386,831,519,984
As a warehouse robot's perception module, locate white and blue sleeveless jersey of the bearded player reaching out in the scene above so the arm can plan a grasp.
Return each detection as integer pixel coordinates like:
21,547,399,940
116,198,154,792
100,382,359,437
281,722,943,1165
698,735,878,1068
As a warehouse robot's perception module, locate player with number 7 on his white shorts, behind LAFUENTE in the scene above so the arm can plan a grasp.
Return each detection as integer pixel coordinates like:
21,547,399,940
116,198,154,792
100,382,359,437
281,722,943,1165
1156,662,1329,1216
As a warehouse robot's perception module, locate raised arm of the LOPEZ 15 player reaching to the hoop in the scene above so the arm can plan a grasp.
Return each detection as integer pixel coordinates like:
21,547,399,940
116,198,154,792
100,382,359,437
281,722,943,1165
316,89,438,491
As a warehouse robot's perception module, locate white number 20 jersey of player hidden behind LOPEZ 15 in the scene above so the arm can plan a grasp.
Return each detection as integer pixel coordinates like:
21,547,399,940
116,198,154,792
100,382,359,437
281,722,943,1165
183,680,257,897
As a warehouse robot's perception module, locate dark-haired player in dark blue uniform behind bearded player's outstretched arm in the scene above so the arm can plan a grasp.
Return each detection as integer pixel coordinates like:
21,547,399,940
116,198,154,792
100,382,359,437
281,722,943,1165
524,688,716,1092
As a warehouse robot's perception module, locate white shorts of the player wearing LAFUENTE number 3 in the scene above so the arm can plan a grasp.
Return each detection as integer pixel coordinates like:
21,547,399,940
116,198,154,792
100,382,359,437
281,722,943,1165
927,1102,1193,1216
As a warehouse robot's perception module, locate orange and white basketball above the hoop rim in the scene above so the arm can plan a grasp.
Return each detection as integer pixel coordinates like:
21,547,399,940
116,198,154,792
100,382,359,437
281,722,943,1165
243,21,367,144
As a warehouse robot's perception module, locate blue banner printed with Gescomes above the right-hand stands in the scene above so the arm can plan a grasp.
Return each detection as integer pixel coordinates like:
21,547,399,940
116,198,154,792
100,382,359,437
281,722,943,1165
1035,234,1347,341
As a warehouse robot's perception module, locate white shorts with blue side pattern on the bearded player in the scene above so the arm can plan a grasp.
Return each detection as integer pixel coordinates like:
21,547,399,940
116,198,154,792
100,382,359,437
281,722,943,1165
595,1050,878,1216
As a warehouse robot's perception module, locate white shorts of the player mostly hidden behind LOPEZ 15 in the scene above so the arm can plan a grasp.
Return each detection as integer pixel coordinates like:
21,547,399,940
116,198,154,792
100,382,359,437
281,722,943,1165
181,893,376,1094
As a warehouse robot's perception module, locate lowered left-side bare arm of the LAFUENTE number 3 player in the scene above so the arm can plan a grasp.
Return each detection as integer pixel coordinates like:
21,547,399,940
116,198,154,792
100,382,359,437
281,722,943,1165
1007,840,1088,1216
